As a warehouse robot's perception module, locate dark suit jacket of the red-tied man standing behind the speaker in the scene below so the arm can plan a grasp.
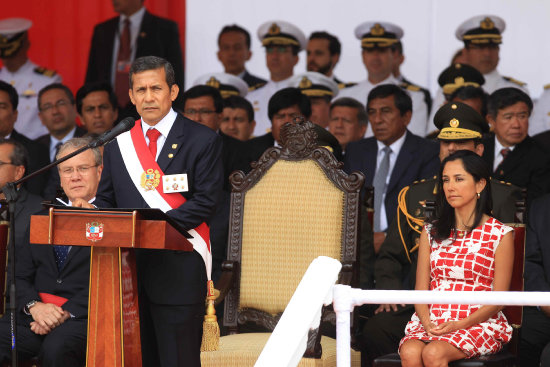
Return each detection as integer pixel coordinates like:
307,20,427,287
86,11,185,112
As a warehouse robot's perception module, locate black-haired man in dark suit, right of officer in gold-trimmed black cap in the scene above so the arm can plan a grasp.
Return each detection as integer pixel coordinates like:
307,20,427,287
483,88,550,203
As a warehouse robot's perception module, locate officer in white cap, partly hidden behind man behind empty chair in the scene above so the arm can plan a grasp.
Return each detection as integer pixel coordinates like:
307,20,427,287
289,71,339,129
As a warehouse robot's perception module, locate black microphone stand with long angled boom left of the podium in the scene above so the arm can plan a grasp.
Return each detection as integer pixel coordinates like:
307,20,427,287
0,132,121,367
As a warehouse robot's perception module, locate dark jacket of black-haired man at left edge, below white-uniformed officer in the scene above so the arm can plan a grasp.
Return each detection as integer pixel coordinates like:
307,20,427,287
10,130,50,195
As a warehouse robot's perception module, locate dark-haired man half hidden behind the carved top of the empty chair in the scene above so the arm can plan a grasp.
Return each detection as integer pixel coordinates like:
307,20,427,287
245,88,342,170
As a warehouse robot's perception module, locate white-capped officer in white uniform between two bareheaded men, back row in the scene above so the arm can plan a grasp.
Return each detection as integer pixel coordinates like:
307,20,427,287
246,20,307,136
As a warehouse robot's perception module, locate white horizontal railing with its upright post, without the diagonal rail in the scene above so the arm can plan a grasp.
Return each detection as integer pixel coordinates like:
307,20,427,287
333,285,550,367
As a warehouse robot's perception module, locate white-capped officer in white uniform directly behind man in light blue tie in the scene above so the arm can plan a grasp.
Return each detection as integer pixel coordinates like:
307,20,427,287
339,22,434,137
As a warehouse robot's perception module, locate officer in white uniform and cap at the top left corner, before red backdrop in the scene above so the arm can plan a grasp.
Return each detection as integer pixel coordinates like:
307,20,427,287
0,18,61,139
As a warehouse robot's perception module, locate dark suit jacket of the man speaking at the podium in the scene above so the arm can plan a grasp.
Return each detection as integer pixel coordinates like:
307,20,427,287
94,114,223,305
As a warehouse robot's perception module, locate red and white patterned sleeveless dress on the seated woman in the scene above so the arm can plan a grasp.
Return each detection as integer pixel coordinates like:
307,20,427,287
399,218,512,358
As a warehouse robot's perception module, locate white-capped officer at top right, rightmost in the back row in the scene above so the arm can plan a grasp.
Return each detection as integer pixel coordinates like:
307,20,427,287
455,15,529,94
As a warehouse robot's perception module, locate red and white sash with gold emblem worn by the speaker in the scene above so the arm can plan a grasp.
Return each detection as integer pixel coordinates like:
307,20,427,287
117,120,212,280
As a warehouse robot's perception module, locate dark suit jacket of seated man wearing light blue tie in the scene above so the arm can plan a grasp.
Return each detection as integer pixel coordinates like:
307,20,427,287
344,131,439,230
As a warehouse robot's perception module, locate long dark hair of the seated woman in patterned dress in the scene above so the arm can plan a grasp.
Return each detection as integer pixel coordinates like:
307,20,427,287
431,150,493,240
